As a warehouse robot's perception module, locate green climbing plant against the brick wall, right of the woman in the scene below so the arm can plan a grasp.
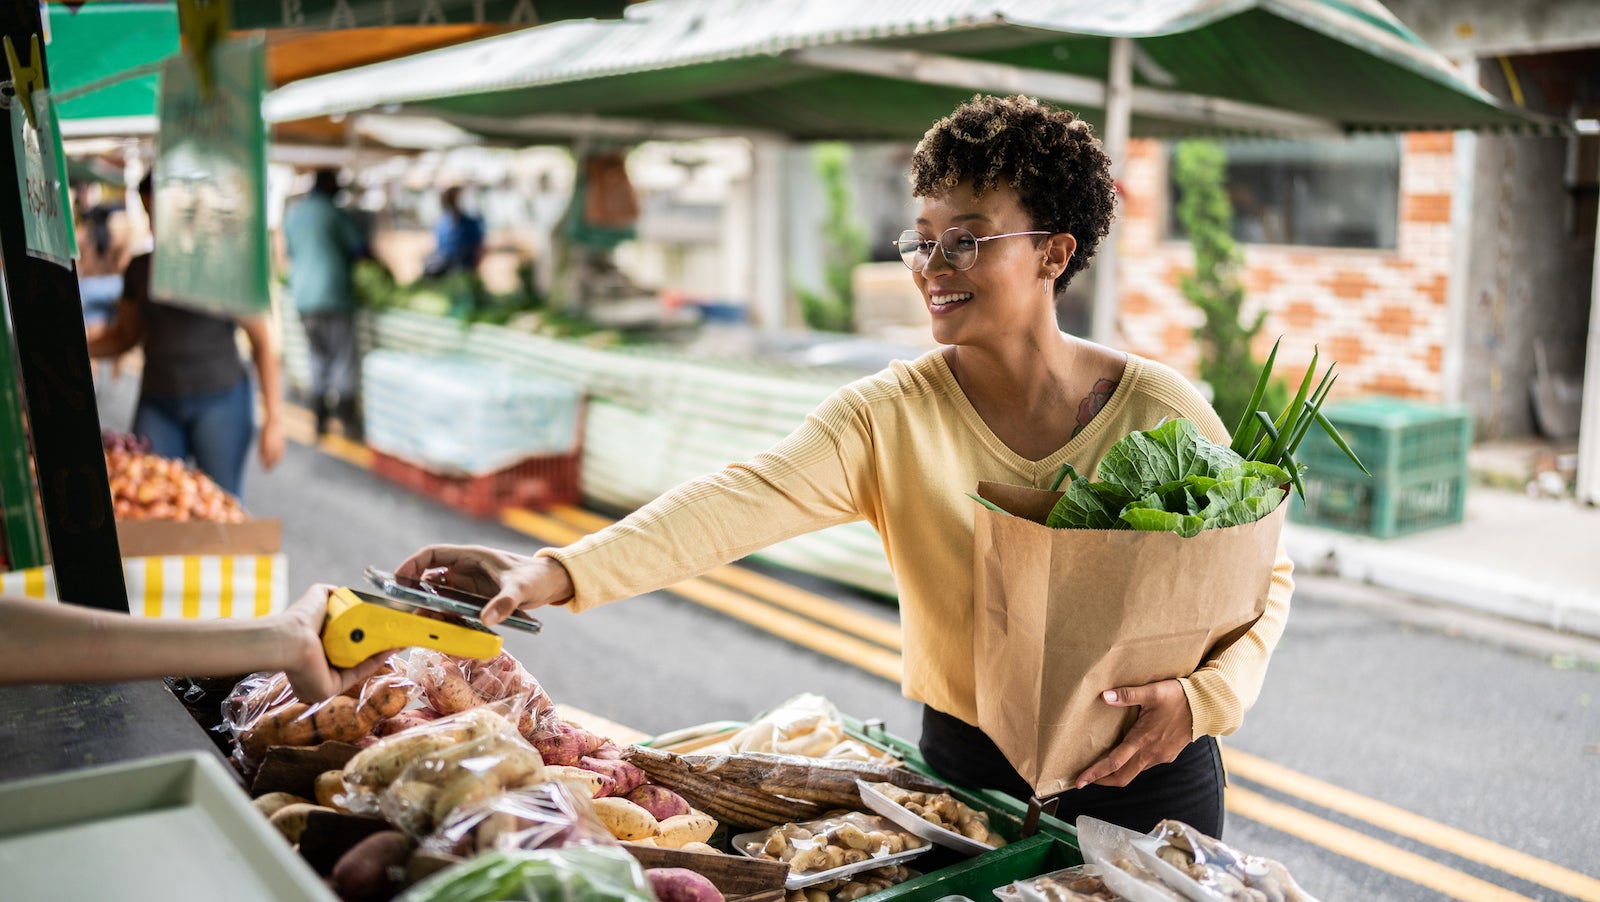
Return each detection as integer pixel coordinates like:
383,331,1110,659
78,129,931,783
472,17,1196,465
1173,141,1288,425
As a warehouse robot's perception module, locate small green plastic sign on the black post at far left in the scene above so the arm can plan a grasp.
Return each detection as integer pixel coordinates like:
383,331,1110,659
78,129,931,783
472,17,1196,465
11,88,77,269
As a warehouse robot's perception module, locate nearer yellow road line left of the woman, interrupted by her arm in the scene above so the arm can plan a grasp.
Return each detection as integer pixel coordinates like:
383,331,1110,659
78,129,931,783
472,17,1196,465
501,509,902,683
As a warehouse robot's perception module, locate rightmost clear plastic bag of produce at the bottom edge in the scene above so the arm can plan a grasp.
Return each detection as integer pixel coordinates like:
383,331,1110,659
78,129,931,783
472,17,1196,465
1134,820,1317,902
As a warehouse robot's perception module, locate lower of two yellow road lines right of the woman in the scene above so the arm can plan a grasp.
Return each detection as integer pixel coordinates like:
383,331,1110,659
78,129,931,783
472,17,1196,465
1227,787,1531,902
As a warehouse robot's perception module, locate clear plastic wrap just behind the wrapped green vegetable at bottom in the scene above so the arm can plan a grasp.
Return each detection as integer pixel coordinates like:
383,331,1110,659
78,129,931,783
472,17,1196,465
421,780,618,857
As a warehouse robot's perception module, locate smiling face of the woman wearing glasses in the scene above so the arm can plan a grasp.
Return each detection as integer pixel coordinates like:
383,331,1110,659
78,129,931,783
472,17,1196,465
912,182,1064,344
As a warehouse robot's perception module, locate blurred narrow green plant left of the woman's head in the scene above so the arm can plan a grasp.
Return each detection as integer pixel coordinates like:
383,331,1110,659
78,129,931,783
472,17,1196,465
795,142,867,333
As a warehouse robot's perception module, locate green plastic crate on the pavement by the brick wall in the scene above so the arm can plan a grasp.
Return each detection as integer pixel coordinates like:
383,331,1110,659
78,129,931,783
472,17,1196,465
1290,398,1472,539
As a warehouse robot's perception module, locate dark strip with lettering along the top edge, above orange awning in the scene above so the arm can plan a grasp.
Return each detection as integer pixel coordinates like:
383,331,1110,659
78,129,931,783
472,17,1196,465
232,0,627,30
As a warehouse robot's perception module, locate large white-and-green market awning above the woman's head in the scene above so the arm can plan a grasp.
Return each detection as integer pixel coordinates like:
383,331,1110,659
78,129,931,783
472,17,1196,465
266,0,1561,139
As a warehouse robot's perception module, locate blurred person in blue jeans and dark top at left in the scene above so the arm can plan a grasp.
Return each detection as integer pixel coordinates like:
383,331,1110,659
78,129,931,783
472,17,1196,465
90,176,283,497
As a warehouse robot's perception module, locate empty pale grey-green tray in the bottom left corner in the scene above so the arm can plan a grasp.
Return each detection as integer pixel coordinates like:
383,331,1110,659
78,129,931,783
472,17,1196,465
0,752,336,902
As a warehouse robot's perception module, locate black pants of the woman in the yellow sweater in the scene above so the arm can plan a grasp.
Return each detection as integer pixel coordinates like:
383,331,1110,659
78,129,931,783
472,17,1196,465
918,705,1222,840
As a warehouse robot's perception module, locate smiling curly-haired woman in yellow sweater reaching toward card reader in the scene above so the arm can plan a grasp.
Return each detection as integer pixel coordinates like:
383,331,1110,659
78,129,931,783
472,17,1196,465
400,98,1293,836
